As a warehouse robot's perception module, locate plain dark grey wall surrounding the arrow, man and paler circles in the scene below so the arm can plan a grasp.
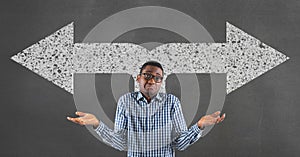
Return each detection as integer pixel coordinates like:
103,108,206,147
0,0,300,157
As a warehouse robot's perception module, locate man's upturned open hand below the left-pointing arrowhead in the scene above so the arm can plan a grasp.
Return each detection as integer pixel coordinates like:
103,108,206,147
67,111,100,129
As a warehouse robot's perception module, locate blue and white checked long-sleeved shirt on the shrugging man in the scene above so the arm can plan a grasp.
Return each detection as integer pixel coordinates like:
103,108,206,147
95,92,203,157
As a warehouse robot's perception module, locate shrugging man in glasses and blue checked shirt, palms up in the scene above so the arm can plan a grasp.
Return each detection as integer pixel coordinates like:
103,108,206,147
67,61,225,157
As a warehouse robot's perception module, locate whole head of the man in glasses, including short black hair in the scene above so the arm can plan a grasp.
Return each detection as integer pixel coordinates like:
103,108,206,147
137,61,164,99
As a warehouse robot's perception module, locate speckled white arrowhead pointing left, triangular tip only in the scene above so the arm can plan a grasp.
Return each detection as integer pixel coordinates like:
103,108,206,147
11,23,74,93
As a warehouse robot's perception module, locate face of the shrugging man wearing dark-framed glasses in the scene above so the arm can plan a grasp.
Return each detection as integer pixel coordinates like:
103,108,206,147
137,65,163,98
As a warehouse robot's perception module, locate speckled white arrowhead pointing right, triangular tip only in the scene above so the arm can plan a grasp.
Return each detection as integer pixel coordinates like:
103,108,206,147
225,22,289,93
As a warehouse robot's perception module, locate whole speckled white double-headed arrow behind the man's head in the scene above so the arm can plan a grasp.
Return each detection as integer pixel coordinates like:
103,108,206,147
11,22,289,93
